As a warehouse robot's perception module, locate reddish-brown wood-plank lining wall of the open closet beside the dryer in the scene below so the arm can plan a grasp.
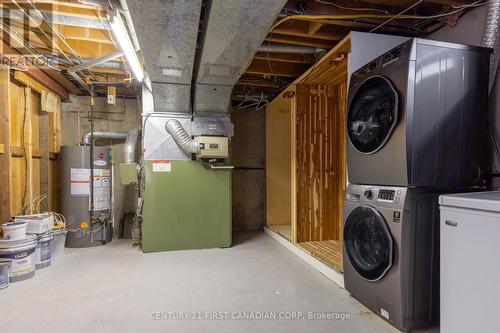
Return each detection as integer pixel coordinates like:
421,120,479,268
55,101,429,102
296,83,347,242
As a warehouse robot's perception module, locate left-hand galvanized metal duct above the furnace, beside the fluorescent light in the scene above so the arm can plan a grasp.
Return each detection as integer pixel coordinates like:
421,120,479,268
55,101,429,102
128,0,201,113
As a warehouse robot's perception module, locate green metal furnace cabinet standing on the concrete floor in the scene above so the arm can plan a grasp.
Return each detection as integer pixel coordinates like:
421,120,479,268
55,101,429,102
142,161,232,252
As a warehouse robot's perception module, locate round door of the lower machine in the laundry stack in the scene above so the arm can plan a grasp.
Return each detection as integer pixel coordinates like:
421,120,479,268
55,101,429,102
344,206,393,281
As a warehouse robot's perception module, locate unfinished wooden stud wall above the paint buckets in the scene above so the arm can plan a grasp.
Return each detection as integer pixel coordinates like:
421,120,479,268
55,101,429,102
0,69,61,223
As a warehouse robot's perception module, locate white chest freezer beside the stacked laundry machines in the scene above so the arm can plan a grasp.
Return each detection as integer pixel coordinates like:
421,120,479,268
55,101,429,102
439,191,500,333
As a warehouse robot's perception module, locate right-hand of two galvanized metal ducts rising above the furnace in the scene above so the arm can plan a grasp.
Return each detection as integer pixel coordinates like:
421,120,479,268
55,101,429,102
194,0,286,113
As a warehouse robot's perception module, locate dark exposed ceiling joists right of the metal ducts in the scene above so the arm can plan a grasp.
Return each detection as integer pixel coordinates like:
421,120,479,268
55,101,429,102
232,0,487,106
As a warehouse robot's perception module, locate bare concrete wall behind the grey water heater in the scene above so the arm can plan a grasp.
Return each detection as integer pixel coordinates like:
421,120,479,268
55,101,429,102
62,95,141,235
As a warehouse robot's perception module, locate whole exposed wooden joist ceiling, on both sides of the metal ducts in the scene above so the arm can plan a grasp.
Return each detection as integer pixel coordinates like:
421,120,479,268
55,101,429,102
0,0,487,105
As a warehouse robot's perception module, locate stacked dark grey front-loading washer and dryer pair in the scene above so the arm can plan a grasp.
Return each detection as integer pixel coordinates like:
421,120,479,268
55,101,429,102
344,38,490,331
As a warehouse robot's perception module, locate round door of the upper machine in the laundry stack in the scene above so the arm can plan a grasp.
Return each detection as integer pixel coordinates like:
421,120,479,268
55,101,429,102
347,75,398,154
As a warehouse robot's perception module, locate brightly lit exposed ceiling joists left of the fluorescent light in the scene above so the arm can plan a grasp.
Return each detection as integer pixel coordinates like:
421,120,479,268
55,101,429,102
0,0,140,96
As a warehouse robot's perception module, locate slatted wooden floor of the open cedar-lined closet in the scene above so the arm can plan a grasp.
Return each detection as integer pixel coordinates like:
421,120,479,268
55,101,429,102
297,240,343,272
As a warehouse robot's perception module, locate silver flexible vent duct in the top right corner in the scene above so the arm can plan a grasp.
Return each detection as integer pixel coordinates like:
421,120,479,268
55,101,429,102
482,0,500,92
